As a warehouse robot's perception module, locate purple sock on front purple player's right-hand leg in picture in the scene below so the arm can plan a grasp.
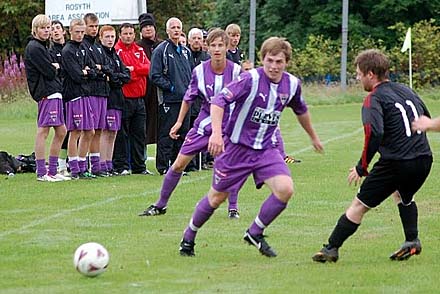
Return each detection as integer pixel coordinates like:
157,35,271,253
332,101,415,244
249,194,287,236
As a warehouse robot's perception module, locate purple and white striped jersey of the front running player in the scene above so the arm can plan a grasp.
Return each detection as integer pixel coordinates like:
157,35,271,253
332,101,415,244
212,67,307,150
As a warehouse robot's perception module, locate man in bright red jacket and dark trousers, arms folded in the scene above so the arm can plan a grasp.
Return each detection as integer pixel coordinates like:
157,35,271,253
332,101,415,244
113,23,151,175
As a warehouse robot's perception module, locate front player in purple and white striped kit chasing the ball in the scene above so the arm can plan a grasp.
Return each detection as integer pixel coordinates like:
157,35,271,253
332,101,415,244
180,37,323,257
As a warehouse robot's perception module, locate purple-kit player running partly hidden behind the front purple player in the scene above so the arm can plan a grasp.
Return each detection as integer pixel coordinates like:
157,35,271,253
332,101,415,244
139,29,241,216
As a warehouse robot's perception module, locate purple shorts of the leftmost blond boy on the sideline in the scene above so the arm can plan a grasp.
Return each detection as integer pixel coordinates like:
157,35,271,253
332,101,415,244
37,98,64,128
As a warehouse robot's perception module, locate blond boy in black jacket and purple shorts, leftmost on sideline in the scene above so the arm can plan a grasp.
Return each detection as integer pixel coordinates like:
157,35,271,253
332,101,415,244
24,14,70,182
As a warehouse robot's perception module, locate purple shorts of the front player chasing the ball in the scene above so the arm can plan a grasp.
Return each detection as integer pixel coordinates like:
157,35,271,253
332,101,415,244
212,137,291,192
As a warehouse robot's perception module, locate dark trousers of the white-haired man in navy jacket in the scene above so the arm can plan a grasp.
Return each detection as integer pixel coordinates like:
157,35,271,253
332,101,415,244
156,103,190,174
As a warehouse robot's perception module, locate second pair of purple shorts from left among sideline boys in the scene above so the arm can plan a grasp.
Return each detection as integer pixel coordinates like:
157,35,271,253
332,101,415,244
66,97,95,131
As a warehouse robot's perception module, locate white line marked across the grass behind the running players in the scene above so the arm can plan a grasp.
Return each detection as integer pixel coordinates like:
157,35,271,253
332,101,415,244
0,128,363,239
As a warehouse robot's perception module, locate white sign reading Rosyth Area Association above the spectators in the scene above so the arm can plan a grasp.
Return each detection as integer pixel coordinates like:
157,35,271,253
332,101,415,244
45,0,147,26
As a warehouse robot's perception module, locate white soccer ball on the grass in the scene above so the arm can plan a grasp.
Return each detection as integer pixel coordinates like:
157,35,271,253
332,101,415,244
73,242,110,277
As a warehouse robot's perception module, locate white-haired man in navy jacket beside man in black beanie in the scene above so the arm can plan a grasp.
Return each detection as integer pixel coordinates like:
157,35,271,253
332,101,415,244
150,17,192,175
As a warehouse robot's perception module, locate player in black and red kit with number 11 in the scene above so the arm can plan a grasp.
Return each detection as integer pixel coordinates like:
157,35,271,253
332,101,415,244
312,50,432,262
